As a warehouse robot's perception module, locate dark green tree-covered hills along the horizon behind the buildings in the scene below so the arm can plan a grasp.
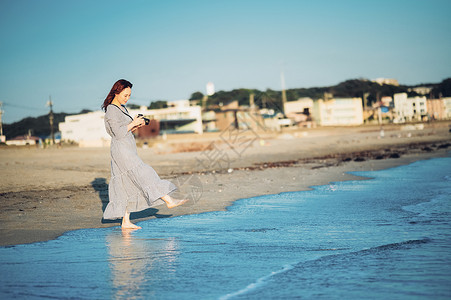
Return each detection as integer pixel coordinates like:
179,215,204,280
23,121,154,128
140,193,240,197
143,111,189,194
3,78,451,139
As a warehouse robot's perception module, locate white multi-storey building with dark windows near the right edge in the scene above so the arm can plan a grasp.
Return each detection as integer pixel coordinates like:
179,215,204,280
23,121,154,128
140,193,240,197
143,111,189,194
393,93,427,123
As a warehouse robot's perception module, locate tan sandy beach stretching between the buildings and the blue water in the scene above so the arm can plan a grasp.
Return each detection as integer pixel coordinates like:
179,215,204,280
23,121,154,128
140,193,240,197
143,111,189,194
0,122,451,246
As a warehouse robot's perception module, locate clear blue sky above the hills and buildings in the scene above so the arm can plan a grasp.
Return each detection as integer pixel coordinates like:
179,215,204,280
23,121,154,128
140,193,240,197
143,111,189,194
0,0,451,123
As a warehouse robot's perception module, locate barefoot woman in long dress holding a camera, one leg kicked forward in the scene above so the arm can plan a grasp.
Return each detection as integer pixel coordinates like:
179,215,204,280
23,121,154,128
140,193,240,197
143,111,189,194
102,79,188,229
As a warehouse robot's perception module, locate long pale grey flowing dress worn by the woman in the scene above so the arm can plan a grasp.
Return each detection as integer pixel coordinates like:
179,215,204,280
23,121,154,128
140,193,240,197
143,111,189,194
103,104,177,219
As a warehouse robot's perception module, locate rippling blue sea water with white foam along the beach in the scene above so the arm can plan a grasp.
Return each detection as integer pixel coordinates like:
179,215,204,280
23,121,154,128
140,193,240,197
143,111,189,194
0,157,451,299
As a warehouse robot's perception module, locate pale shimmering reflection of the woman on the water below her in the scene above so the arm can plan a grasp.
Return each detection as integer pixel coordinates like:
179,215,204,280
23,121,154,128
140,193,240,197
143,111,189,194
106,229,178,299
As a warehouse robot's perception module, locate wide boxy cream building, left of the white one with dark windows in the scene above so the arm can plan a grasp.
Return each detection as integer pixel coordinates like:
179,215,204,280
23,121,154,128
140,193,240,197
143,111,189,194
313,98,363,126
